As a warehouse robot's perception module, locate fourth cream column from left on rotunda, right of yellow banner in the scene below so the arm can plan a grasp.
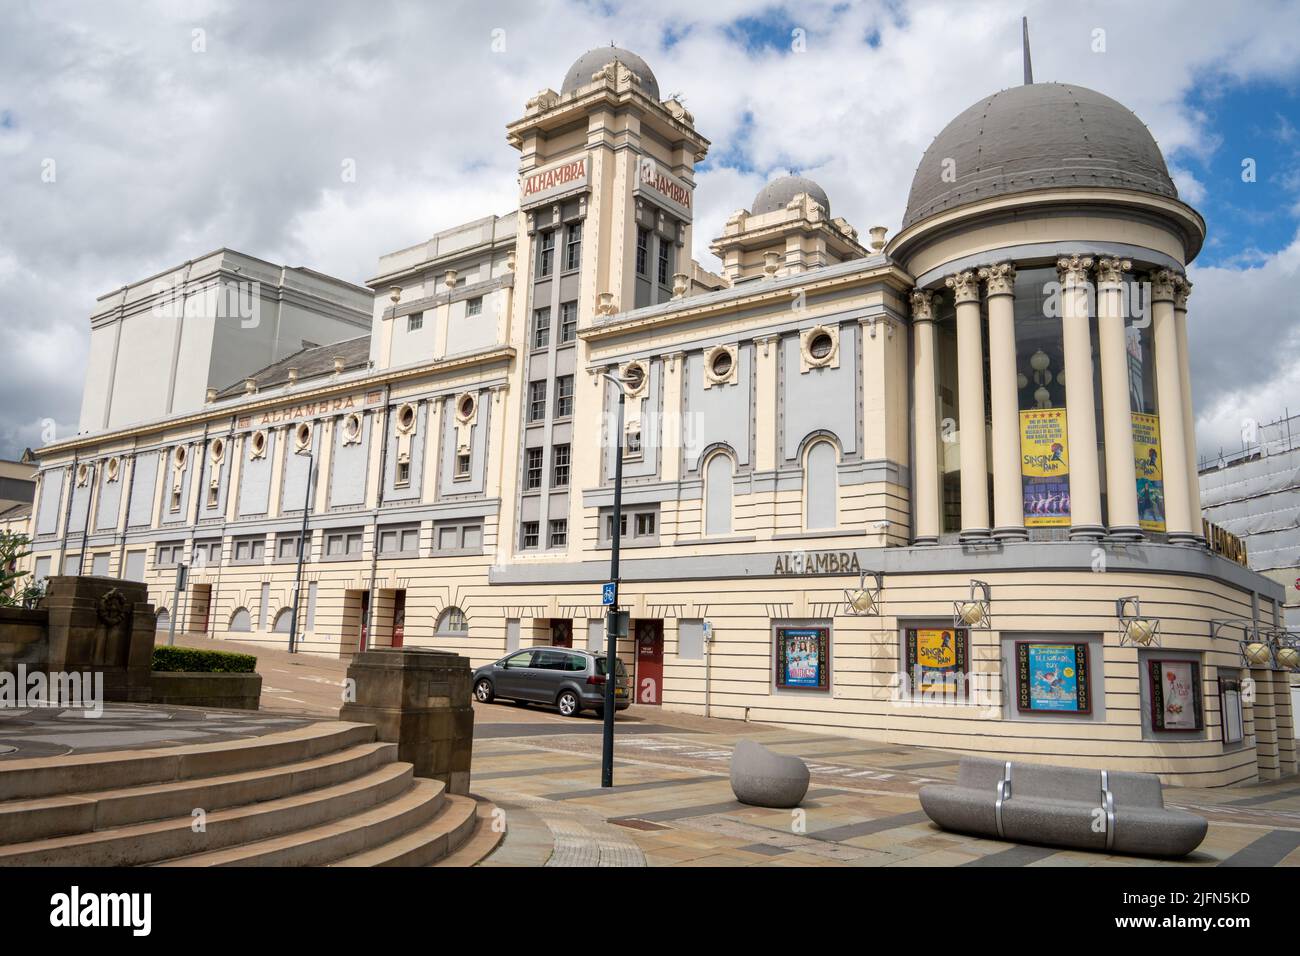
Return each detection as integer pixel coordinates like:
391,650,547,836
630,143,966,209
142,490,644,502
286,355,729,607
1057,255,1102,538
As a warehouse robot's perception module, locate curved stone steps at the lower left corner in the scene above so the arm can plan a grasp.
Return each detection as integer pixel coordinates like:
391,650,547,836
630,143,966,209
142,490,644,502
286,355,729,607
0,721,501,866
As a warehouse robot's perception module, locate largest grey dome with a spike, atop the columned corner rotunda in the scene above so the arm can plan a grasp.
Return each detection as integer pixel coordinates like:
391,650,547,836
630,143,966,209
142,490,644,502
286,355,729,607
902,83,1178,229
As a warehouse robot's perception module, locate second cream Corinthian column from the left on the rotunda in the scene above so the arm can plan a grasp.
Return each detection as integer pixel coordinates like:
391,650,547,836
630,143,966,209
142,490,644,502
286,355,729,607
944,272,988,541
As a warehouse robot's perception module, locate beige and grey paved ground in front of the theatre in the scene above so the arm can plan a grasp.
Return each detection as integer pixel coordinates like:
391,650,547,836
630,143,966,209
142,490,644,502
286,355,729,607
142,637,1300,866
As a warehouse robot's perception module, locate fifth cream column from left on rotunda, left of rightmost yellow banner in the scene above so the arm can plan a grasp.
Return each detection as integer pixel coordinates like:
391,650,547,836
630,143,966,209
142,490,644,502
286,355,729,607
1097,259,1143,541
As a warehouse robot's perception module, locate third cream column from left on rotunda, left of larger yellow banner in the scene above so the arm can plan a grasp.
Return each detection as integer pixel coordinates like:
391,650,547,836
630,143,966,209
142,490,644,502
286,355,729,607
982,263,1028,541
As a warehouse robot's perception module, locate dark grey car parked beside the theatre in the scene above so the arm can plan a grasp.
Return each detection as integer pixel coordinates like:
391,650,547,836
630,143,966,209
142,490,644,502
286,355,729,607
475,648,632,717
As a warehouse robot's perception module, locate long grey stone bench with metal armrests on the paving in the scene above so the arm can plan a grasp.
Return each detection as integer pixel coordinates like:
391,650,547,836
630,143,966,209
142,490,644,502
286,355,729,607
920,757,1208,857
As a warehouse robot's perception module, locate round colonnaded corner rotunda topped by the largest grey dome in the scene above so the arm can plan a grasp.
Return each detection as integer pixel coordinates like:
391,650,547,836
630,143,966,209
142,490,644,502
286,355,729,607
888,83,1205,544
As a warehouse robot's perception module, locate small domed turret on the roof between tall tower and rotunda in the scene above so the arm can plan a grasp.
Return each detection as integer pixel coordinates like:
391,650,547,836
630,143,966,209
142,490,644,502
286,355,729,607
710,176,868,282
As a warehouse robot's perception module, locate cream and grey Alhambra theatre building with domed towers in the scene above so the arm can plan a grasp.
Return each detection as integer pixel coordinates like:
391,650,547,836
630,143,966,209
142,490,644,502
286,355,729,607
25,48,1300,786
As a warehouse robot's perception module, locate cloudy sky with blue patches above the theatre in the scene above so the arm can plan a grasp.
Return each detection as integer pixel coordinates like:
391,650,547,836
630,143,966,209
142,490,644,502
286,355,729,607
0,0,1300,457
